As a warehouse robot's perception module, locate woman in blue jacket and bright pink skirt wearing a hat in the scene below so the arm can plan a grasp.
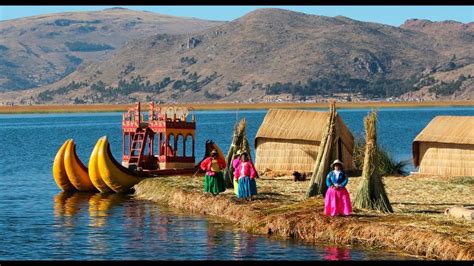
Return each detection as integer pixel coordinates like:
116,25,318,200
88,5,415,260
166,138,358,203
324,160,352,216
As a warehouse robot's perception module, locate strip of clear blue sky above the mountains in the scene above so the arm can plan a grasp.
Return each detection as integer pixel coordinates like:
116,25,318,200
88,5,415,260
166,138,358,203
0,6,474,26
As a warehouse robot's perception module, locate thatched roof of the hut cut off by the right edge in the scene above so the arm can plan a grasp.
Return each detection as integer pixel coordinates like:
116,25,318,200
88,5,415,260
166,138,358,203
412,116,474,166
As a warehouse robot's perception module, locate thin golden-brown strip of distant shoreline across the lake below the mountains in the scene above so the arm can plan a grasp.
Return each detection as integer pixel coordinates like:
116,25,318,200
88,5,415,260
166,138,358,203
0,101,474,114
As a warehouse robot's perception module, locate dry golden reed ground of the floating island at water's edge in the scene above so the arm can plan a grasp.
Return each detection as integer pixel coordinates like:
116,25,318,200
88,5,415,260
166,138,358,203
134,176,474,260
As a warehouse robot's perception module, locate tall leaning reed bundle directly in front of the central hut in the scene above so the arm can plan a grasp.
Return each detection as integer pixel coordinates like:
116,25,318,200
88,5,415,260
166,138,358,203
305,101,340,198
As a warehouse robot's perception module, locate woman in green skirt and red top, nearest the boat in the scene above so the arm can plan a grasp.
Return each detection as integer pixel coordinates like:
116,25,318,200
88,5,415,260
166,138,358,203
201,149,226,195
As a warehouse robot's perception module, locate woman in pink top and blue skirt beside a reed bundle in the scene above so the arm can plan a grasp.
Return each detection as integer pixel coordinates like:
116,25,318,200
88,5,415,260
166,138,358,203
234,152,257,201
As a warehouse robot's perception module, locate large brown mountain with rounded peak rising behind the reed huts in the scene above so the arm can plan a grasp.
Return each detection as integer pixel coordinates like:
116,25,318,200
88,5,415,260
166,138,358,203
1,9,474,103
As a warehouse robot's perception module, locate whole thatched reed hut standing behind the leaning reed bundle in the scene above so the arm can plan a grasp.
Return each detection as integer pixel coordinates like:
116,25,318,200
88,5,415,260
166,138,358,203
255,109,354,174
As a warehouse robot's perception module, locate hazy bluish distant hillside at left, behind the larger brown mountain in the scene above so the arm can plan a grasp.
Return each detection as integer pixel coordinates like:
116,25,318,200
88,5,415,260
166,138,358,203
0,8,222,91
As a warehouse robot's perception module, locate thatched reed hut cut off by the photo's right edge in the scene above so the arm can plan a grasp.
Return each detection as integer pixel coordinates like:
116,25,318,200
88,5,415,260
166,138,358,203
412,116,474,176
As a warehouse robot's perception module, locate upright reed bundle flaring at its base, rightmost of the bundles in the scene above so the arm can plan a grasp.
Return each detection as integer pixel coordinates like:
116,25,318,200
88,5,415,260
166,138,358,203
353,111,393,212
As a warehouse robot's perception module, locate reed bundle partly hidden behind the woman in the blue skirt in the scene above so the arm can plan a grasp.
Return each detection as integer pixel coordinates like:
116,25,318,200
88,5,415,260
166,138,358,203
224,118,258,188
